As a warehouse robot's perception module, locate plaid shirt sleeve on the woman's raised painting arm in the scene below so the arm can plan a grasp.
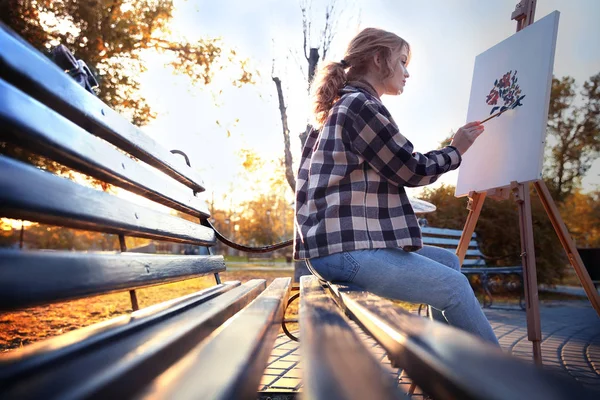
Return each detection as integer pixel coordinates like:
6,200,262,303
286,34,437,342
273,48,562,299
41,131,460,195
344,96,462,187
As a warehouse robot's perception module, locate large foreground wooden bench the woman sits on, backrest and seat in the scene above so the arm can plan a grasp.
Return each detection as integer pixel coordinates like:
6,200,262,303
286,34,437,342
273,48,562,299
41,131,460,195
0,23,591,400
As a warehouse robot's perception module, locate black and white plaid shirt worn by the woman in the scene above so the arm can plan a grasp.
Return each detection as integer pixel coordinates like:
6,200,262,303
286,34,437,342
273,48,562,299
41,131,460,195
294,82,461,259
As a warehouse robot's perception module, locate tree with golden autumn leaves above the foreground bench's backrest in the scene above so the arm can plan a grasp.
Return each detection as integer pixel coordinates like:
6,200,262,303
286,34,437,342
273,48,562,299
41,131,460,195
0,0,253,125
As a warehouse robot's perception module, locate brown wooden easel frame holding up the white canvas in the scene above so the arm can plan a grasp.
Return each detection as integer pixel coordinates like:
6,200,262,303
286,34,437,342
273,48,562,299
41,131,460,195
456,0,600,365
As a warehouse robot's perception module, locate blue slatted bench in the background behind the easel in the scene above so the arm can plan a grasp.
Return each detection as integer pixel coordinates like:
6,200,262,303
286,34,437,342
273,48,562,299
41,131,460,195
421,226,525,310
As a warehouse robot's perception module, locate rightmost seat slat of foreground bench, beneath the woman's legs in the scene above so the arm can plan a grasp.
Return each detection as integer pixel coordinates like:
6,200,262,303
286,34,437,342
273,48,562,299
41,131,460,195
330,285,591,400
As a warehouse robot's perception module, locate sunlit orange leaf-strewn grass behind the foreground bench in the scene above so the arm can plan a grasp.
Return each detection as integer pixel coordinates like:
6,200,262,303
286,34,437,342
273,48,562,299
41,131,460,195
0,269,582,351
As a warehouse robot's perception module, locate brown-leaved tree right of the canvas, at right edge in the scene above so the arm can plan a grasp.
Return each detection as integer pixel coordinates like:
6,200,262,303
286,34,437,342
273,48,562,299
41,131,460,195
546,73,600,203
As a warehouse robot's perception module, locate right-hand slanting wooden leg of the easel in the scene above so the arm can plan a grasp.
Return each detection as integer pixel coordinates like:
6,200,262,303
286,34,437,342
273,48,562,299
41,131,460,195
534,180,600,316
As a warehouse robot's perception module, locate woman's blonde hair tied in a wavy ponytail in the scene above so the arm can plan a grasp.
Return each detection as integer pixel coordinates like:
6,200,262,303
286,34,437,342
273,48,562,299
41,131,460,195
311,28,410,128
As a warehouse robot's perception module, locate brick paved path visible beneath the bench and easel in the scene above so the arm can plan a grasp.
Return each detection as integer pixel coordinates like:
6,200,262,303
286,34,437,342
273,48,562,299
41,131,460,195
259,301,600,399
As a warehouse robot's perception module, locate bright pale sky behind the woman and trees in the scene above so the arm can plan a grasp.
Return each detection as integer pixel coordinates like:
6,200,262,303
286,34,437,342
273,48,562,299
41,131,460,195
141,0,600,206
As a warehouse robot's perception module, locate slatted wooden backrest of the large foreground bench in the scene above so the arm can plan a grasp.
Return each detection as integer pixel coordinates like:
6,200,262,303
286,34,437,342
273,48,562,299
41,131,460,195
0,26,224,311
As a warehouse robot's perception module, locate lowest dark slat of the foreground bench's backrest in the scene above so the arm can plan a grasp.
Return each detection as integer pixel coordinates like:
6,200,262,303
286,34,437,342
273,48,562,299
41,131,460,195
0,250,225,311
